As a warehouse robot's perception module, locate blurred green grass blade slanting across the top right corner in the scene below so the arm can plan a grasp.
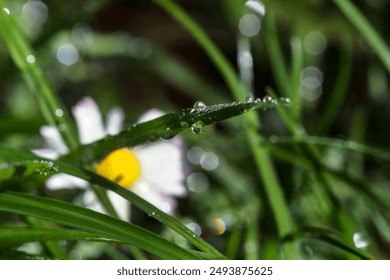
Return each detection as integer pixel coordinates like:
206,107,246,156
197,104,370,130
333,0,390,73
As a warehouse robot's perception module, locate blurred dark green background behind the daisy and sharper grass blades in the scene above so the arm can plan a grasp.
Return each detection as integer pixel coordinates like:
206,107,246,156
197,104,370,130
0,0,390,259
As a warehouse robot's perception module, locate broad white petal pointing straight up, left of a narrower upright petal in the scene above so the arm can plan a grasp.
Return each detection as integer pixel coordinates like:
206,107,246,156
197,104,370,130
72,97,106,144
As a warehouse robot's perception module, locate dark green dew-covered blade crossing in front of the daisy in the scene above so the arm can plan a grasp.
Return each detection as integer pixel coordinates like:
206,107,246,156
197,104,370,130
63,99,289,163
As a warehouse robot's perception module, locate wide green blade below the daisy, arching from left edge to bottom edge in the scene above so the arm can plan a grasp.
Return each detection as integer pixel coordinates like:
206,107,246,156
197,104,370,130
0,193,201,259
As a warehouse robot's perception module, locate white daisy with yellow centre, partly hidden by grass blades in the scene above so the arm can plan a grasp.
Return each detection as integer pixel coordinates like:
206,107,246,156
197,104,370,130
33,97,186,220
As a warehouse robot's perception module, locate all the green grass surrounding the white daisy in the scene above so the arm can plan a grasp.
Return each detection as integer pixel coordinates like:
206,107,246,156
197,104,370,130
0,0,390,259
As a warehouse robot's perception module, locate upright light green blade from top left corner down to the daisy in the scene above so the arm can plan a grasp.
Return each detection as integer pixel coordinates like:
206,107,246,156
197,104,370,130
0,3,78,149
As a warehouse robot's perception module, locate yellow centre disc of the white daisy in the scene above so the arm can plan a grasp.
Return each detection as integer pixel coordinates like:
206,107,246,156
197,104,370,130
95,148,141,188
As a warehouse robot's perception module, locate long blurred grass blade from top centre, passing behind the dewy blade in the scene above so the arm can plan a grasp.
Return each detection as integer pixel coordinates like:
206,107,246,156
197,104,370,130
154,0,299,259
